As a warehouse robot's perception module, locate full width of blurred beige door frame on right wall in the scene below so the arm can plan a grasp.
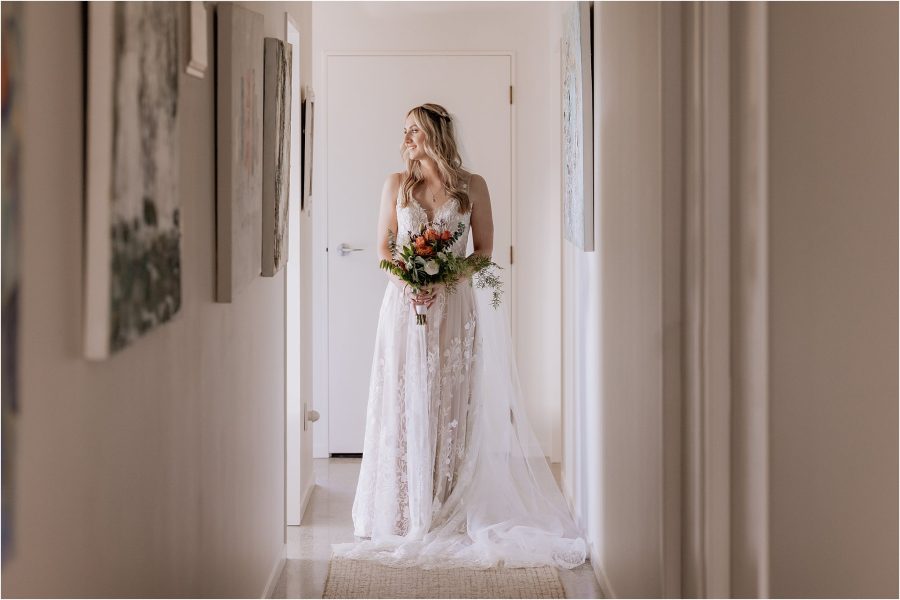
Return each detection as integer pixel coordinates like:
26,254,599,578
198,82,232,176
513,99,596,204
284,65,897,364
680,2,769,598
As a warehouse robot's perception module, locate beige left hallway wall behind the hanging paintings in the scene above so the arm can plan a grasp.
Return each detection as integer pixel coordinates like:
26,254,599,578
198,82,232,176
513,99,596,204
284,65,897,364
3,3,310,597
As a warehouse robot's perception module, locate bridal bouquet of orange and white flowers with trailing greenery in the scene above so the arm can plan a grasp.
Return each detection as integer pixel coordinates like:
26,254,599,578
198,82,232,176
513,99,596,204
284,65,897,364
380,223,503,325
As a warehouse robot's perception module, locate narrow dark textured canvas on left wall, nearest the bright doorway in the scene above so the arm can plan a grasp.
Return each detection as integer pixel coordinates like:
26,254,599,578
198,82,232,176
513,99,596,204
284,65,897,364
262,38,291,277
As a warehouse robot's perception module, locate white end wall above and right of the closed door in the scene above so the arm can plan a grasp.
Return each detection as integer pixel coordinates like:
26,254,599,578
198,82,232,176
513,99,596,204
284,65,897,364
313,2,560,457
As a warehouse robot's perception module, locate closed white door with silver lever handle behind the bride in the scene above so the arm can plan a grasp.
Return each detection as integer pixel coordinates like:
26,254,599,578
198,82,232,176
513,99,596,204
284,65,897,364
325,55,512,454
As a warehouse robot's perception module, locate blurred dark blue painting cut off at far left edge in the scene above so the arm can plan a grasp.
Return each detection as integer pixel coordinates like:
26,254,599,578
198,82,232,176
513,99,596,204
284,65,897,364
0,2,22,563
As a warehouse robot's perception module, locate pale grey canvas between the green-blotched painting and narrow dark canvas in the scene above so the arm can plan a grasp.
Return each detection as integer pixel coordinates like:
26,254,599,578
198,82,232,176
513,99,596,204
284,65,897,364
216,3,263,302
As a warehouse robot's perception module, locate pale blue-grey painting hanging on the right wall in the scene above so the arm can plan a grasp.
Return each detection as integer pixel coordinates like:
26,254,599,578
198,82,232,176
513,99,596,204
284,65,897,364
562,2,594,251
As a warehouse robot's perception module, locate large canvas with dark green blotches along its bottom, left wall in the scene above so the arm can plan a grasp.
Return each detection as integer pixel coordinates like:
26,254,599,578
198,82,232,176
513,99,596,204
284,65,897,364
85,2,181,360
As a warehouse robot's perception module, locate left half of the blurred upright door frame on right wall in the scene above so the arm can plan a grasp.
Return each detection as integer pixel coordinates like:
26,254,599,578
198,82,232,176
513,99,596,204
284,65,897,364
681,2,731,598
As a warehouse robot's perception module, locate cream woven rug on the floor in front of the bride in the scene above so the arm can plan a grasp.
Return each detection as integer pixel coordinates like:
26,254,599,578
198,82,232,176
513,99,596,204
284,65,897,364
322,558,565,598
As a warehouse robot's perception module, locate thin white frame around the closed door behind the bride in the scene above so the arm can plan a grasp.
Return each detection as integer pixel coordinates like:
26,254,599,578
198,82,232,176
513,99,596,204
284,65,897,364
310,50,518,458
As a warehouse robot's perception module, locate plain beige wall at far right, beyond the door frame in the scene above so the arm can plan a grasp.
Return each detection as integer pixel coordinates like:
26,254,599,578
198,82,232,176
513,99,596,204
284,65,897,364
768,3,898,597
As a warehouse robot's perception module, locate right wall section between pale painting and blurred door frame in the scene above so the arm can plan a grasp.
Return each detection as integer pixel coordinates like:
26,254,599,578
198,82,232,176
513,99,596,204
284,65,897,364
557,2,679,597
